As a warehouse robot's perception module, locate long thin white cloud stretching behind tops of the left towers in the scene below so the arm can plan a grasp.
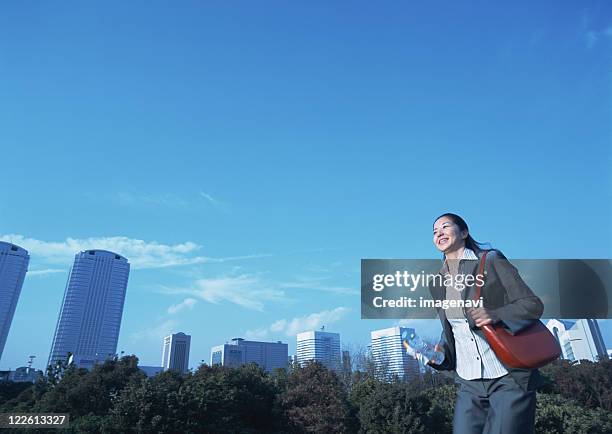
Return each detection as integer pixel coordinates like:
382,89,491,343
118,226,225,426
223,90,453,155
0,234,271,269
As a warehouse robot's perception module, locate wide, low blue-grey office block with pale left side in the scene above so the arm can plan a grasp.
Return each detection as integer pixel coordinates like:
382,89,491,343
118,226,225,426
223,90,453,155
210,338,289,372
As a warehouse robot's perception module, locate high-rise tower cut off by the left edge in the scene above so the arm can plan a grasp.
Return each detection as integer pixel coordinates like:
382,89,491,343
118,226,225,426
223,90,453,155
0,241,30,359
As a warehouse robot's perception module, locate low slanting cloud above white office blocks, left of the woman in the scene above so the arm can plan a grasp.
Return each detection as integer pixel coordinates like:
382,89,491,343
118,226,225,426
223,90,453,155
245,306,350,339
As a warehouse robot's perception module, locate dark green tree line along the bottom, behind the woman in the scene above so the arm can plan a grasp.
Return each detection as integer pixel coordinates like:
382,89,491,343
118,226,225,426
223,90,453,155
0,356,612,434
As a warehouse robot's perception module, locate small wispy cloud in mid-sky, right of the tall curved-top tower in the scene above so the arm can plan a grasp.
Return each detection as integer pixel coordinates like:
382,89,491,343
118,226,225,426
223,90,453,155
163,274,287,311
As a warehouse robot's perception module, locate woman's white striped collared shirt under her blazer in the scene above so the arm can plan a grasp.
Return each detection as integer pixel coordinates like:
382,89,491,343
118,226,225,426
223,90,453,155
446,248,508,380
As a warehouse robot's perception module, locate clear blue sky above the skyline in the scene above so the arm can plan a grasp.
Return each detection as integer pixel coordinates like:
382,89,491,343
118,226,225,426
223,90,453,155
0,1,612,368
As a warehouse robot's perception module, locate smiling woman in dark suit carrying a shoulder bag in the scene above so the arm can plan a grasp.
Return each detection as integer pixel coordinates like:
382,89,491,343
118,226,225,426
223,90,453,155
430,213,543,434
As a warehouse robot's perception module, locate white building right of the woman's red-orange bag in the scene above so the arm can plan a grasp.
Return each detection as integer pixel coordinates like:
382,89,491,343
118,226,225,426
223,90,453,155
546,319,608,362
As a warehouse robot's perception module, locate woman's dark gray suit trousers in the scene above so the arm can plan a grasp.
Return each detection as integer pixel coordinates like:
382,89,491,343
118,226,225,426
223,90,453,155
453,374,536,434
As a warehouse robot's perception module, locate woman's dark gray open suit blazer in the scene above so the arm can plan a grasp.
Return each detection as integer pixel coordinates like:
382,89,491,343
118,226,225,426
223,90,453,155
429,250,544,390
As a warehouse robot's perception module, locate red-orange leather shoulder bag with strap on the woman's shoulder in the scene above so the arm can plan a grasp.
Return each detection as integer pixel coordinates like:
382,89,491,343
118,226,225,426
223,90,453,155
474,252,561,368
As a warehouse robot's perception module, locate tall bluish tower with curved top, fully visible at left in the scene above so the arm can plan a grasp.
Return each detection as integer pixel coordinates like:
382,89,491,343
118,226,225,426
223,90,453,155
49,250,130,369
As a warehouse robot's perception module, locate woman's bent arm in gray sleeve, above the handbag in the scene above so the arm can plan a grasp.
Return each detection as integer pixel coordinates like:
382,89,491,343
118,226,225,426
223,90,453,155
487,251,544,334
